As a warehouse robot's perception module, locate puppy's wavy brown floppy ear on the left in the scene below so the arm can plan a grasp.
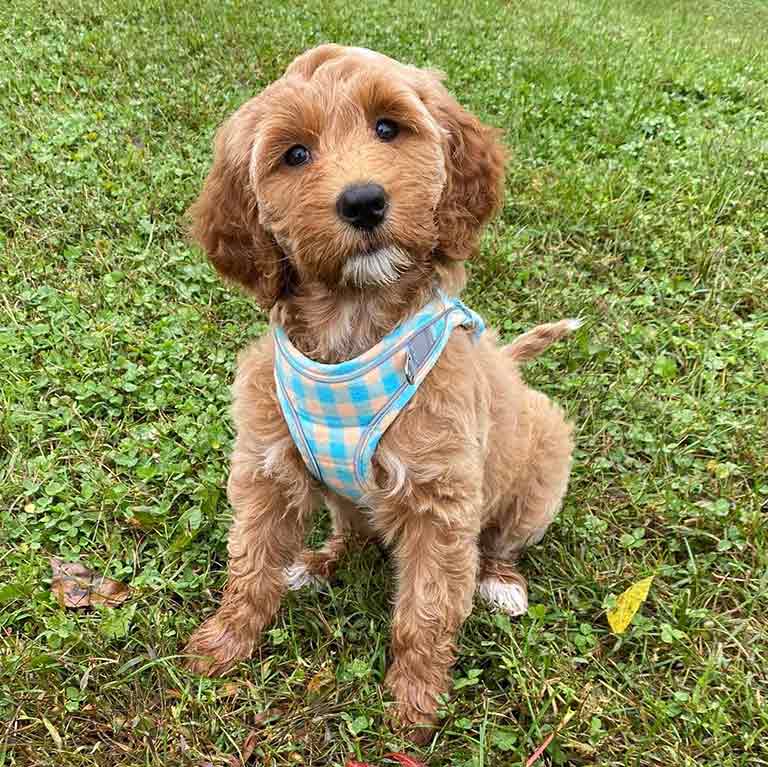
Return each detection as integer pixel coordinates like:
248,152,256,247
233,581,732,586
188,101,287,311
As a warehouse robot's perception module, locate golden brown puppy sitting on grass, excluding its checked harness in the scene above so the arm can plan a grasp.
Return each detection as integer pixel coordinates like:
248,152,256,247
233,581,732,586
187,45,573,740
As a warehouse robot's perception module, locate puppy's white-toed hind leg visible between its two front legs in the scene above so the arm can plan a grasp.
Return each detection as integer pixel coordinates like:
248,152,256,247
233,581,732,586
285,492,374,591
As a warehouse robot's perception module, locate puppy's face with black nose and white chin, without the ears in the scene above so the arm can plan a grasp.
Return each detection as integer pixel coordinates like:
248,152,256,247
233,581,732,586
250,50,446,287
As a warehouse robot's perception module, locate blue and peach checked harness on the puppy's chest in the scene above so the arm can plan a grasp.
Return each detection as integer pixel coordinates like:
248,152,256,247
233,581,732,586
274,291,485,501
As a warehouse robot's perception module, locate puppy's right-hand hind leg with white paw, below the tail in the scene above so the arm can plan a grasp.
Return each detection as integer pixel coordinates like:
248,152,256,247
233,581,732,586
477,391,573,616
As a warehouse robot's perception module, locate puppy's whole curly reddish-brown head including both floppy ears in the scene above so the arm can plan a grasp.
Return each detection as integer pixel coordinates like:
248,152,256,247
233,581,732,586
190,45,503,309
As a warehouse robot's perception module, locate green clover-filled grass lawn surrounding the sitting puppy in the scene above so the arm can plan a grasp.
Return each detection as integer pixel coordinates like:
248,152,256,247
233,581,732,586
0,0,768,767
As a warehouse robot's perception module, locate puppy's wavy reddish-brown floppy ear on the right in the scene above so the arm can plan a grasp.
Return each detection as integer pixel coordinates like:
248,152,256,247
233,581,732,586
420,72,504,261
